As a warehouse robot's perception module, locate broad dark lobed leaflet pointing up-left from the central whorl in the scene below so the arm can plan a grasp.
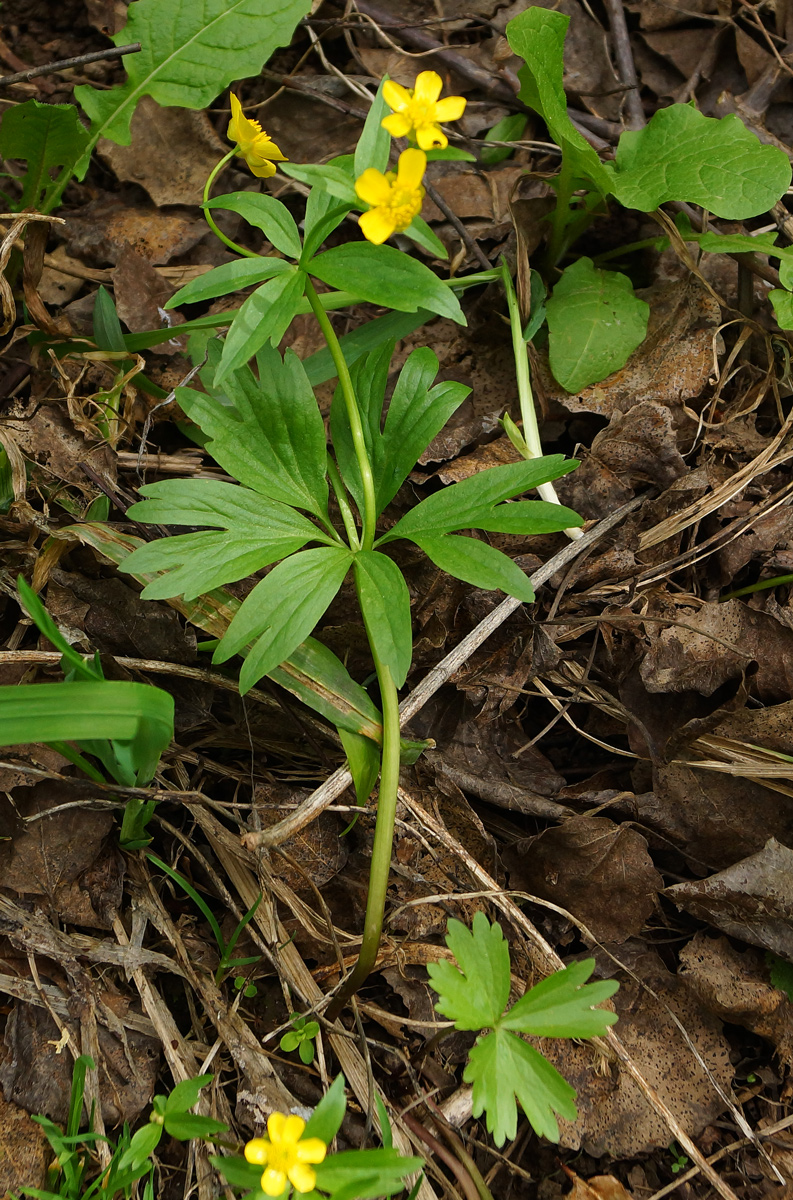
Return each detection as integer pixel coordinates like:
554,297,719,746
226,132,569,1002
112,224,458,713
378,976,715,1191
176,347,328,520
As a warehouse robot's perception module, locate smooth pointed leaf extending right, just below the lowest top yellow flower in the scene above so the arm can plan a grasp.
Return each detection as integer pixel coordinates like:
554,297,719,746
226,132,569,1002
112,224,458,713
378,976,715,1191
306,241,465,325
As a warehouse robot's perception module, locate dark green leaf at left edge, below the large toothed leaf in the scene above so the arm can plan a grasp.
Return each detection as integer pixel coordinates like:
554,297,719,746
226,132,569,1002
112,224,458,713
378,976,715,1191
0,100,89,212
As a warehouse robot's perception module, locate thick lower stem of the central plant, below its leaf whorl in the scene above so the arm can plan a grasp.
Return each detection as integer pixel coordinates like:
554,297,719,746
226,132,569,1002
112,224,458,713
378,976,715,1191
328,642,401,1020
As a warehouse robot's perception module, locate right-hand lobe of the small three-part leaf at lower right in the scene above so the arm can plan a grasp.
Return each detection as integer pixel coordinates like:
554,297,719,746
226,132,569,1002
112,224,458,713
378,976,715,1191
500,959,619,1038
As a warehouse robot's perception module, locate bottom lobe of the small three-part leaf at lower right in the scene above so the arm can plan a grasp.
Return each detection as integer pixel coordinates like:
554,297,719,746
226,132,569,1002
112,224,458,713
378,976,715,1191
463,1030,578,1146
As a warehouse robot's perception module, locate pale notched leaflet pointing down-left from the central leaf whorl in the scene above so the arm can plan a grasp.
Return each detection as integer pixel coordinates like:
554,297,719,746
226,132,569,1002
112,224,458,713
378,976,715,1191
212,546,352,695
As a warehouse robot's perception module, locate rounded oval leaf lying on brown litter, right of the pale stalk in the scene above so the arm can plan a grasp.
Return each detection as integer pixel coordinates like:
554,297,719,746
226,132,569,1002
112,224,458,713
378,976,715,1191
547,258,650,392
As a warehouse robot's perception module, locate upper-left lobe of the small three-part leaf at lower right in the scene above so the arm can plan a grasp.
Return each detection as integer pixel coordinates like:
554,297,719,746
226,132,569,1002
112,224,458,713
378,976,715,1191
427,912,510,1027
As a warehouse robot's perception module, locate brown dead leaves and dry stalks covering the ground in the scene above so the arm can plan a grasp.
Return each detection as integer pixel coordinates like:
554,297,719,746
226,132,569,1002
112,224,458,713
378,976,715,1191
0,0,793,1200
